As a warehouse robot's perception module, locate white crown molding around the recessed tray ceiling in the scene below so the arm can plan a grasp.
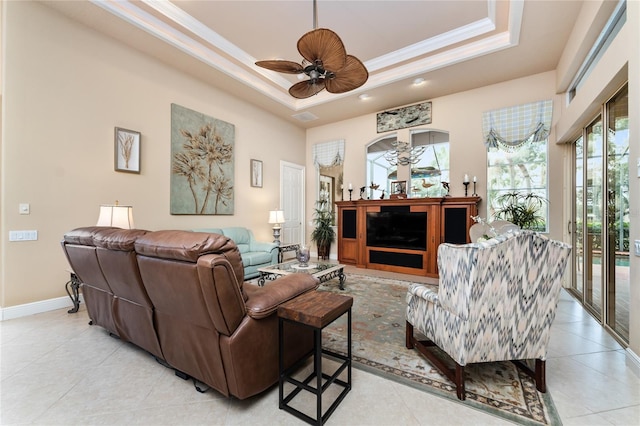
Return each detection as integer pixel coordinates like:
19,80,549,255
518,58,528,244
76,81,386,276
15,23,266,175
90,0,524,112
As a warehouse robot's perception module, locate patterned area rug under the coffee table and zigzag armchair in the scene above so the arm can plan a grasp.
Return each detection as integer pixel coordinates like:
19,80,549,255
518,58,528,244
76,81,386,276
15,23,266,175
319,274,561,425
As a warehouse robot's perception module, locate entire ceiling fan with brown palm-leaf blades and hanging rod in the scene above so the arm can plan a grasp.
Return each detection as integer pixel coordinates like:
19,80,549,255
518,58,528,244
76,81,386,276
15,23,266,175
256,0,369,99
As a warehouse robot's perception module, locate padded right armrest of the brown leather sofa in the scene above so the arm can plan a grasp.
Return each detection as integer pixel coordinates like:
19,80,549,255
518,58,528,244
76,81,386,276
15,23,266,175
244,274,320,319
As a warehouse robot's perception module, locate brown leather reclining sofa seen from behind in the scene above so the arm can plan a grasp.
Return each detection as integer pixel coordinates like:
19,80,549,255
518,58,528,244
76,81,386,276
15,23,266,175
62,227,318,399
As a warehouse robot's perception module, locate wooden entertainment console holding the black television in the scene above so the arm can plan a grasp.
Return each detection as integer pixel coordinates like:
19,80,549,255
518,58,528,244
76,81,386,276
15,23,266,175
336,197,480,278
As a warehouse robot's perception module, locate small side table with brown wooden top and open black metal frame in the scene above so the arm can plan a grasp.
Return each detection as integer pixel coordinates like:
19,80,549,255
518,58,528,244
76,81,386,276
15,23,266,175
278,291,353,425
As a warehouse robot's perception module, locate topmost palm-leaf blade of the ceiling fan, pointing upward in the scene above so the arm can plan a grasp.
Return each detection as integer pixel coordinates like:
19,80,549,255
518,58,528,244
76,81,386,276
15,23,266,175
298,28,347,72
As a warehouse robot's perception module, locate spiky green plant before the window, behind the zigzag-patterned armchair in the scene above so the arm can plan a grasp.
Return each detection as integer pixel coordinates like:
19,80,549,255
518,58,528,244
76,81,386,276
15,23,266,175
493,191,547,230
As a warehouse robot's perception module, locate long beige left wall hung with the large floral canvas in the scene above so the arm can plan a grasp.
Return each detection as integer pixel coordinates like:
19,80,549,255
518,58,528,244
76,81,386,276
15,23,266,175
0,2,305,308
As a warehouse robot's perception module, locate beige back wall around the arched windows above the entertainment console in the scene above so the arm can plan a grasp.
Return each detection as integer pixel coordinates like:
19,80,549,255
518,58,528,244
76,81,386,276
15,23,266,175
307,72,566,246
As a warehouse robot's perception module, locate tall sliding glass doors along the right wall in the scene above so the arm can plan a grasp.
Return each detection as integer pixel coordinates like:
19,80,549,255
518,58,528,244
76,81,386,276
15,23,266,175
572,82,629,342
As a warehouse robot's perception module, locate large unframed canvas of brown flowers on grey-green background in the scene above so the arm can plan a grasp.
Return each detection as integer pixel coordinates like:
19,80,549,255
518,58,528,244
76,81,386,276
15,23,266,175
170,104,235,215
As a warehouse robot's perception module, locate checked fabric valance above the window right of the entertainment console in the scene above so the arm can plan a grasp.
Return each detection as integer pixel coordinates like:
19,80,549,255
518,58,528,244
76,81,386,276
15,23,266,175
482,100,553,151
